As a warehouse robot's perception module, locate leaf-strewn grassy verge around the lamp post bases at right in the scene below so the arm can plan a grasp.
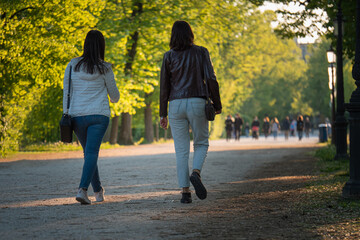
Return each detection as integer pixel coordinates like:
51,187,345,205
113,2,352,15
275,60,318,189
299,145,360,239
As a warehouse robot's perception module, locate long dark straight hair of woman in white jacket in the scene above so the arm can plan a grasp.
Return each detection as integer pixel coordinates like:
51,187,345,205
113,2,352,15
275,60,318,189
75,30,107,74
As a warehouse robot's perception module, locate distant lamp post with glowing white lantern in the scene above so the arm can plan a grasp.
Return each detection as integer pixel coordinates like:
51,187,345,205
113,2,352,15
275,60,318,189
326,46,336,145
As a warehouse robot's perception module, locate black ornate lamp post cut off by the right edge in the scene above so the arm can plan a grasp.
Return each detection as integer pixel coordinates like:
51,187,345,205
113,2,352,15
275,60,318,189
343,0,360,199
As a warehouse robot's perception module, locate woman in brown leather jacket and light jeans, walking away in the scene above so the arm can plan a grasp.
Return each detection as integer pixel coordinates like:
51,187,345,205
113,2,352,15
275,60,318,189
160,21,222,203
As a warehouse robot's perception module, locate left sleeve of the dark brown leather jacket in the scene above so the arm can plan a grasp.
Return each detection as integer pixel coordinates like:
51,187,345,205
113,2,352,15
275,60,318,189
159,52,171,117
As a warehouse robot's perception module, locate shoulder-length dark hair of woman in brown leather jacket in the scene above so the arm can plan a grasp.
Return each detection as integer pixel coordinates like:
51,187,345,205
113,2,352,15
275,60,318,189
170,21,194,50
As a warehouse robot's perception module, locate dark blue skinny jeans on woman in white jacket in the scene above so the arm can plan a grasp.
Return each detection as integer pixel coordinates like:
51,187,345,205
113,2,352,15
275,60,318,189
72,115,109,192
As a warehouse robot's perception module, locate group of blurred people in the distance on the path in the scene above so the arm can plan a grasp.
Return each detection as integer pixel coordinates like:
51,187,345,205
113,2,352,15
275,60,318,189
225,113,311,141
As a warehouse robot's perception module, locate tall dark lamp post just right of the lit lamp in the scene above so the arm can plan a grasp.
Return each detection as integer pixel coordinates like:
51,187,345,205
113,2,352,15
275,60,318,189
335,0,348,159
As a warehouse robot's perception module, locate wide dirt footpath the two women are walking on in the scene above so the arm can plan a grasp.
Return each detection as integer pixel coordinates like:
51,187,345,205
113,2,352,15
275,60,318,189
0,138,318,239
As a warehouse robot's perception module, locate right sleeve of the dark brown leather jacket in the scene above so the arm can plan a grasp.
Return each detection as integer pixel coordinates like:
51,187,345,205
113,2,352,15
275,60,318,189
204,48,222,111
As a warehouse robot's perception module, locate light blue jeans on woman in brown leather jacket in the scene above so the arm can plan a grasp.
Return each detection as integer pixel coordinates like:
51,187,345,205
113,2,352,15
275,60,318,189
169,98,209,188
